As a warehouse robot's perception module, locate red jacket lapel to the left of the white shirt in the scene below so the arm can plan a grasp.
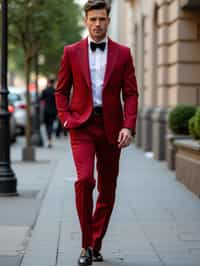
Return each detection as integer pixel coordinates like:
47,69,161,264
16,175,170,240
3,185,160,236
77,38,92,88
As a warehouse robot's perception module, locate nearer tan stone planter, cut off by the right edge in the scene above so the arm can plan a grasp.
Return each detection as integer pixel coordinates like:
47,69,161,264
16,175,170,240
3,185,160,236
174,139,200,197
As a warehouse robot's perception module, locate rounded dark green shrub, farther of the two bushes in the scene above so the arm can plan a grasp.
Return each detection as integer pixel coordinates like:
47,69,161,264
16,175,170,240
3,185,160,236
168,105,196,135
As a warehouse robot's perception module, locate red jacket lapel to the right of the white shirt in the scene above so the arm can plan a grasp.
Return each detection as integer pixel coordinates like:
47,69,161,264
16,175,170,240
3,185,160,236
103,38,118,88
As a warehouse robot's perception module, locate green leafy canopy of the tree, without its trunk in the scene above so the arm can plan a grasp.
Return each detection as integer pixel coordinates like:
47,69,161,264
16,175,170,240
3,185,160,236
8,0,82,74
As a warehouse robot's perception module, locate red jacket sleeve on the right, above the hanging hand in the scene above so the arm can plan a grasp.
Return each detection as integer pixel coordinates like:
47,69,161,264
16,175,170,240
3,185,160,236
122,49,138,135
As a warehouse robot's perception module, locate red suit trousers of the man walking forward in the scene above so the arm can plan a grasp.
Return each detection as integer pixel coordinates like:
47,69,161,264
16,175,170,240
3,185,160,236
70,115,120,250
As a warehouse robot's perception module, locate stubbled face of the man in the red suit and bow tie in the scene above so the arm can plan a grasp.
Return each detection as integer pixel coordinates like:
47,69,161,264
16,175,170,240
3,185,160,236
85,9,110,42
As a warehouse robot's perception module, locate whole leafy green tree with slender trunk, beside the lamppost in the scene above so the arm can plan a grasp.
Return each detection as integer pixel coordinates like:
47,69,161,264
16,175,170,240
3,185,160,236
8,0,81,160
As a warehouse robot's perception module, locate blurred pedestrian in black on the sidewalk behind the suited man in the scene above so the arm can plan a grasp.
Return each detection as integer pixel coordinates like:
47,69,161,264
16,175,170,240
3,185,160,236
40,79,57,148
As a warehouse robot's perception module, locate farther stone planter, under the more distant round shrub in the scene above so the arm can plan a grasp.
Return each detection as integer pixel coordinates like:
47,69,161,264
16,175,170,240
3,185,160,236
166,133,192,170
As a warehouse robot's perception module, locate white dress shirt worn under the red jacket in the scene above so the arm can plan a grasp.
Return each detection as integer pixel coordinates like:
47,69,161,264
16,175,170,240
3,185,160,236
88,36,108,106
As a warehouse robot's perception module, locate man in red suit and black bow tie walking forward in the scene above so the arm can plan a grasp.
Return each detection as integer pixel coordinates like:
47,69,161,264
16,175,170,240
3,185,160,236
55,0,138,265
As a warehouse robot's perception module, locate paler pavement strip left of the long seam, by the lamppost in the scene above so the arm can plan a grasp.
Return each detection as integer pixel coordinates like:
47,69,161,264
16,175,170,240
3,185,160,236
0,135,66,266
